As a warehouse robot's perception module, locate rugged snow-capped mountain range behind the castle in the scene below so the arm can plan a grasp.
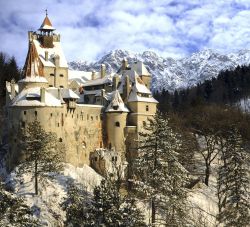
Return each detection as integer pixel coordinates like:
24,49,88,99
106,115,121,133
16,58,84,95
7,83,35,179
69,49,250,91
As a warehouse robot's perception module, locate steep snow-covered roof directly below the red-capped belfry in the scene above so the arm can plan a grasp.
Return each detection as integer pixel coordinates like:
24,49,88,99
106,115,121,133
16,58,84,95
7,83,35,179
33,40,68,68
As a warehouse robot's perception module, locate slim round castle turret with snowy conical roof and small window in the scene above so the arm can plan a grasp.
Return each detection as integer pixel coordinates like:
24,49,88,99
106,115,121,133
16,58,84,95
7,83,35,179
105,90,129,156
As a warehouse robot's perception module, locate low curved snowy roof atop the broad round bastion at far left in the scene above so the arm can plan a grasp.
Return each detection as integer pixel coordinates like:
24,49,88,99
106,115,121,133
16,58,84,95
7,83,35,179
10,87,61,106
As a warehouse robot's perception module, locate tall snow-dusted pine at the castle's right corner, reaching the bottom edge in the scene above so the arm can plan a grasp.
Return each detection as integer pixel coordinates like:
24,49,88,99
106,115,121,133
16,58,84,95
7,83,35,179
135,112,187,226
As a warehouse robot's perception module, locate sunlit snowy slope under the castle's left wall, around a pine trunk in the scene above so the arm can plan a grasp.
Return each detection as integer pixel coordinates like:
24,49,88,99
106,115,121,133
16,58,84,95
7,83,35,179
4,164,102,227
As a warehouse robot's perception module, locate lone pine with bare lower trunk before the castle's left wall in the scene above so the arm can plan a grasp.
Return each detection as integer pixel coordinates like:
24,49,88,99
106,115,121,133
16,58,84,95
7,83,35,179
18,120,64,195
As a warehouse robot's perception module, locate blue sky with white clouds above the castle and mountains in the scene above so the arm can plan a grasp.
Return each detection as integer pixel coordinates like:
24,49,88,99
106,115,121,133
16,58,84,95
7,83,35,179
0,0,250,66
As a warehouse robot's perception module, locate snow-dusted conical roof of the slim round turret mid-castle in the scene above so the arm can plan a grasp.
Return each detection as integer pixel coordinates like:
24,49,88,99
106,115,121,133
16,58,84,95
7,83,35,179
105,90,129,112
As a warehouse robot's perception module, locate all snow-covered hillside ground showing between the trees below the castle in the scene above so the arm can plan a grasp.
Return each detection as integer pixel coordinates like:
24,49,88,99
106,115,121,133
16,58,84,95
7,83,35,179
0,154,221,227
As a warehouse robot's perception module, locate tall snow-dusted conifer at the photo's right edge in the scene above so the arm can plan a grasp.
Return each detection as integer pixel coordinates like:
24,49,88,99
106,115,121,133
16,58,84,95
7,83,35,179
218,129,250,227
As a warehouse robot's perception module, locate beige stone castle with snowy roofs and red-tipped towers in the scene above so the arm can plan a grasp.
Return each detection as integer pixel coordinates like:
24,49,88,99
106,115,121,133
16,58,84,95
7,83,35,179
6,13,157,174
